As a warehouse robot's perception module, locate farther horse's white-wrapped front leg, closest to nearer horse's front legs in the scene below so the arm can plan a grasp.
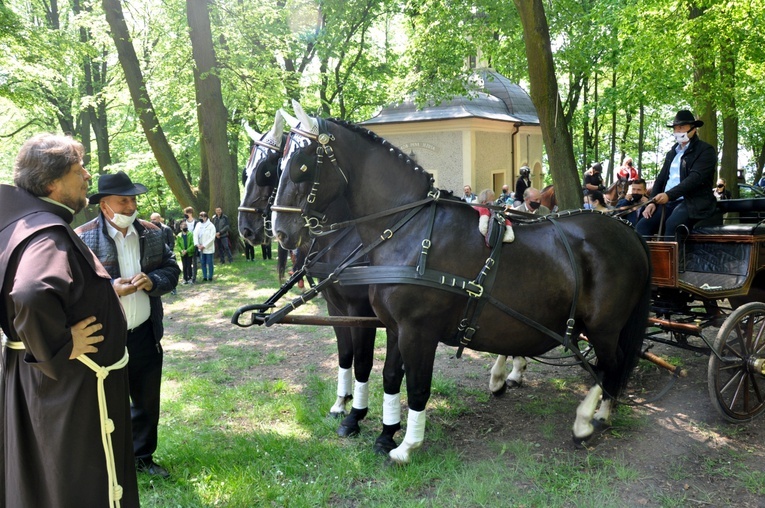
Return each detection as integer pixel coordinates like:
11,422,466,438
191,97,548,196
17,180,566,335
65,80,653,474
337,328,377,437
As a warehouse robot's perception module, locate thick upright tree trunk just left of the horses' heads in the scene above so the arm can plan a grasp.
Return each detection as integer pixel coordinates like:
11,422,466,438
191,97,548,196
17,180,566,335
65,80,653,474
186,0,239,236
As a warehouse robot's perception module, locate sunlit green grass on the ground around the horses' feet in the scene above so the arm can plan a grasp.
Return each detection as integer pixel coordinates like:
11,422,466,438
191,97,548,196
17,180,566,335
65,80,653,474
139,252,765,508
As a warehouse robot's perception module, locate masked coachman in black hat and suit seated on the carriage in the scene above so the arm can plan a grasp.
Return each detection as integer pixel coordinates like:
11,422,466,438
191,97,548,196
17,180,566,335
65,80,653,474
635,109,717,239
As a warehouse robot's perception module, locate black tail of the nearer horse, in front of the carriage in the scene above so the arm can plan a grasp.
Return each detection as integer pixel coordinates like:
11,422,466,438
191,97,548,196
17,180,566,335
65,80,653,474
613,235,651,397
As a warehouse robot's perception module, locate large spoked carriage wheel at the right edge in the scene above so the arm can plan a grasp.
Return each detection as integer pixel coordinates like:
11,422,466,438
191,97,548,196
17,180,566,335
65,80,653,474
707,302,765,422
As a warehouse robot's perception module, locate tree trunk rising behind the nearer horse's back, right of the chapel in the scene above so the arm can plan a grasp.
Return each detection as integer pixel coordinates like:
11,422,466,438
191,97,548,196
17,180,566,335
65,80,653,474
514,0,582,210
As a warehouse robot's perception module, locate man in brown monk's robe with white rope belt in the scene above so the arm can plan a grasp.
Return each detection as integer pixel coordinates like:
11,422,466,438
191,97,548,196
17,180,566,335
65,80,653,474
0,134,139,508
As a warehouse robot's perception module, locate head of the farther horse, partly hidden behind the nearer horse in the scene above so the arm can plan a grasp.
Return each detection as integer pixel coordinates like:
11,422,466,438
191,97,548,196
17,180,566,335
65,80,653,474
239,111,286,245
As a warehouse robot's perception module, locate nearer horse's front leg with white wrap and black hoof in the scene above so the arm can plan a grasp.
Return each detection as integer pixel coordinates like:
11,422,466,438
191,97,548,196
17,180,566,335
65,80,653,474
374,330,404,455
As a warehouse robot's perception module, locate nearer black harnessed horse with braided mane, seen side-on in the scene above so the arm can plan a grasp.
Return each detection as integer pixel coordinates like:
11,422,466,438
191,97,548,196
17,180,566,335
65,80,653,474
273,104,651,463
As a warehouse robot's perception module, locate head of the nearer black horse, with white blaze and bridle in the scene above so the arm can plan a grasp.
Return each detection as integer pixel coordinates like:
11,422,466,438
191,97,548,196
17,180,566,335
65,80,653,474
272,101,348,249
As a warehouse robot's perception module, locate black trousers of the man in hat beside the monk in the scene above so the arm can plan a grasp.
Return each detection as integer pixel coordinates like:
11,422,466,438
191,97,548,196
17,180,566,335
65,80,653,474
127,319,163,460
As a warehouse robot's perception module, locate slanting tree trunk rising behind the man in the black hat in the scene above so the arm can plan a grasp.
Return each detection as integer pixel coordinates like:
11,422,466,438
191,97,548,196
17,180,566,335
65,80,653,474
101,0,197,207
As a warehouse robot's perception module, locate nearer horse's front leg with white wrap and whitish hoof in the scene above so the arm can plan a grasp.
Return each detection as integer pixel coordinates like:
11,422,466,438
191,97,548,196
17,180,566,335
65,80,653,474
389,332,438,464
